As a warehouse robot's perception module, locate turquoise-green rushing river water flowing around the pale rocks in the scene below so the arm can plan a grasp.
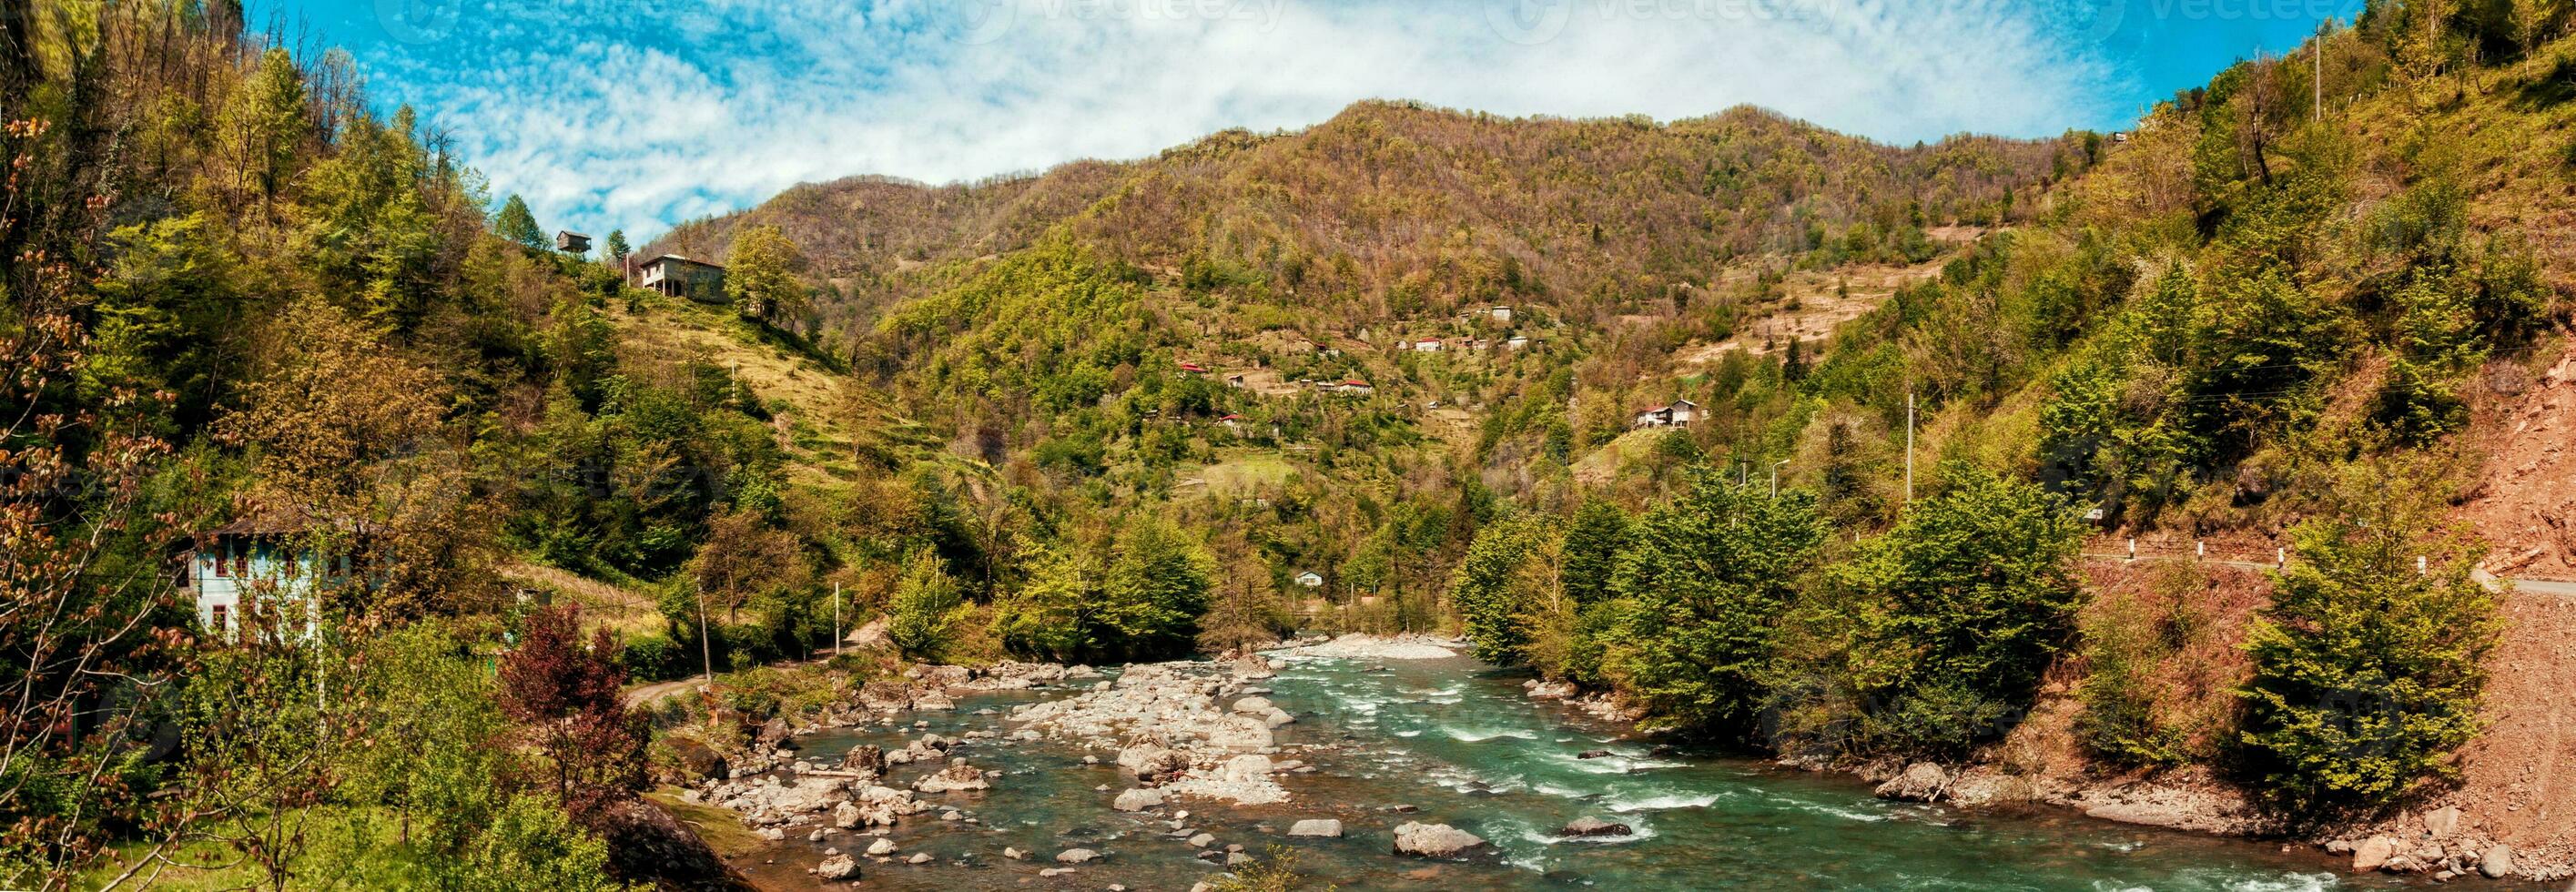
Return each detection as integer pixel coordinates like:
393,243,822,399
783,657,2393,892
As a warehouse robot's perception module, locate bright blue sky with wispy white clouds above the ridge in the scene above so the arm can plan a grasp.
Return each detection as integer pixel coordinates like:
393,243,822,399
250,0,2362,245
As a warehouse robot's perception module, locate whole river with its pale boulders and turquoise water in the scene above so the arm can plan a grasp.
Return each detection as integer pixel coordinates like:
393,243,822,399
688,639,2441,892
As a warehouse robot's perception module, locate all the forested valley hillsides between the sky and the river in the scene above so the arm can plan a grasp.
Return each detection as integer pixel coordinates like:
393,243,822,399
0,3,2576,889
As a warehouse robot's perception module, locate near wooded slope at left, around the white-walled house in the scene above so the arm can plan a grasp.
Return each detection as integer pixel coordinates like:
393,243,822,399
0,3,752,889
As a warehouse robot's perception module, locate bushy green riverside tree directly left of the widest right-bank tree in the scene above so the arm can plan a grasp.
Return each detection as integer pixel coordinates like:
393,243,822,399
1607,467,1826,735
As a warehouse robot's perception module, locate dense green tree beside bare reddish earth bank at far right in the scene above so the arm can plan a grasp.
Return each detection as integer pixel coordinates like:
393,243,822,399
2241,480,2501,807
